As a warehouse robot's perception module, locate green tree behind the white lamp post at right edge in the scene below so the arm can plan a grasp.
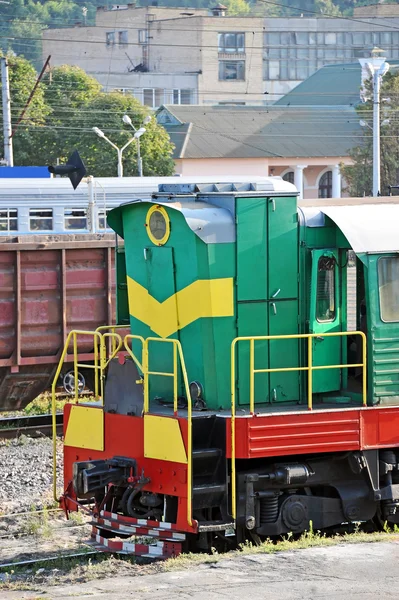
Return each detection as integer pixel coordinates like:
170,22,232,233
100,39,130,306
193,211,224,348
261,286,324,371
341,72,399,196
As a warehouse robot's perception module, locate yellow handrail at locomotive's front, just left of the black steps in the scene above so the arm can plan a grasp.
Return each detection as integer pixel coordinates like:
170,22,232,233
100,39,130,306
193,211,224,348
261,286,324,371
143,337,193,526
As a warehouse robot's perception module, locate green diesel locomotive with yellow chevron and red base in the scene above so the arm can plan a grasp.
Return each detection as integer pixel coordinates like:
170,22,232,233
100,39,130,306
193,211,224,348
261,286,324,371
57,178,399,556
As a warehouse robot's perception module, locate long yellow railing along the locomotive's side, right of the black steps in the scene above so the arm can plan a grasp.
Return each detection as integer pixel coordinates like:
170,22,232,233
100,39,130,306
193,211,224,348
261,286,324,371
231,331,367,520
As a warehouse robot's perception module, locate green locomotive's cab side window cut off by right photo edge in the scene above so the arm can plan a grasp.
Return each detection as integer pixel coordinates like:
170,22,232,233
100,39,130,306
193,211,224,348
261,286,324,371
378,256,399,323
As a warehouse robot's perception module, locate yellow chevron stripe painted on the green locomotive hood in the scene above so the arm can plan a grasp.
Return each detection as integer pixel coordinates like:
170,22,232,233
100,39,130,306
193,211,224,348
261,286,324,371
127,277,234,338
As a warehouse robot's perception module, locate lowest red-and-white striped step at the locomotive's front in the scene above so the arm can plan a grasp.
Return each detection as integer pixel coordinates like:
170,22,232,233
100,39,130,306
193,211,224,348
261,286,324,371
86,527,182,559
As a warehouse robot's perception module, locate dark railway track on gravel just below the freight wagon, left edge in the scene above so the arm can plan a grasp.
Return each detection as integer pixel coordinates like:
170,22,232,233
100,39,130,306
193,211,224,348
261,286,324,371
0,413,63,440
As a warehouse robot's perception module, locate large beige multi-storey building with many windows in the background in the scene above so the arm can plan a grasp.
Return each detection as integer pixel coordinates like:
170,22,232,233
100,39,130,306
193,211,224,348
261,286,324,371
43,4,399,108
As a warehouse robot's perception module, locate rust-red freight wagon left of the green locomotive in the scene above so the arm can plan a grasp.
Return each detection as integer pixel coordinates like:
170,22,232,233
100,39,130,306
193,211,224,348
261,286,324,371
0,234,115,411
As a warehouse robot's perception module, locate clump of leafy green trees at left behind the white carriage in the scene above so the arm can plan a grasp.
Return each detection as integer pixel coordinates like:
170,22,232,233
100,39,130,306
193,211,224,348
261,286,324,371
0,56,174,177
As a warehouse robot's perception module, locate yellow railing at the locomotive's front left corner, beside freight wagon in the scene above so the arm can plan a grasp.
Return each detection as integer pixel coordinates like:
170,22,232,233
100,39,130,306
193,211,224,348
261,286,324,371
51,329,122,500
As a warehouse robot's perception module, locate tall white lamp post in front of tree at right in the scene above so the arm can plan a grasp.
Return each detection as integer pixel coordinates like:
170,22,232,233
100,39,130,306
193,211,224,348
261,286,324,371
365,48,389,196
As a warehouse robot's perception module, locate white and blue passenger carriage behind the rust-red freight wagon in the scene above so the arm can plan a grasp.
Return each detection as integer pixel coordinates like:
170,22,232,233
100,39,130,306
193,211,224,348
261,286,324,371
0,176,294,236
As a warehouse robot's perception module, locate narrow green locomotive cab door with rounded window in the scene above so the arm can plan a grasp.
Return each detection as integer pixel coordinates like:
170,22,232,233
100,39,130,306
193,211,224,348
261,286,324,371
309,250,342,394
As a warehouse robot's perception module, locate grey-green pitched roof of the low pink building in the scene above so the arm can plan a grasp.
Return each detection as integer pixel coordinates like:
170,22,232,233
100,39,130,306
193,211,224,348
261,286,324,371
157,105,362,159
